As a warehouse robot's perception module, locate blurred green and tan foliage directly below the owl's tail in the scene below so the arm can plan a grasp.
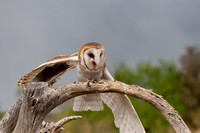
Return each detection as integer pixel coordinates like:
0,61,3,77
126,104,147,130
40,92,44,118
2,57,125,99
46,106,118,133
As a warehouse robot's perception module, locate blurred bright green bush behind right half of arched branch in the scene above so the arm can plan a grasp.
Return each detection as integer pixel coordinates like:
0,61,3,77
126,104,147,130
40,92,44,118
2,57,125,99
114,60,186,133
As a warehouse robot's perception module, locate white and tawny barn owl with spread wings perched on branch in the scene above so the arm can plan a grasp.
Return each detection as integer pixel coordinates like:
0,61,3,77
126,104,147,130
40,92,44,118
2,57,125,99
18,42,145,133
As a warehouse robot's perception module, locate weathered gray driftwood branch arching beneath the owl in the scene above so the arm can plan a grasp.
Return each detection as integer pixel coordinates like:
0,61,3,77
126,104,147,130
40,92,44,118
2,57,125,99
0,80,190,133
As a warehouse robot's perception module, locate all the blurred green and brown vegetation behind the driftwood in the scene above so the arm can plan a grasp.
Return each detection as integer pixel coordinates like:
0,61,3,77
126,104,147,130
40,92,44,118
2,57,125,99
0,46,200,133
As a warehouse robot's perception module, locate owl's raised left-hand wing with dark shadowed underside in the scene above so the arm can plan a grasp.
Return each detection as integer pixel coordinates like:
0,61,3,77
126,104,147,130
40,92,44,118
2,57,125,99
18,53,78,87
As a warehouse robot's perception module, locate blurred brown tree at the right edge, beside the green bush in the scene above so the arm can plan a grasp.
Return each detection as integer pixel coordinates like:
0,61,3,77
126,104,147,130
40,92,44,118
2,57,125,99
180,46,200,128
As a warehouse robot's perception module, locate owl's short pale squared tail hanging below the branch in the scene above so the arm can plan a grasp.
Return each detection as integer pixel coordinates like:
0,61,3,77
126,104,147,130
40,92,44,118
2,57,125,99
73,94,103,111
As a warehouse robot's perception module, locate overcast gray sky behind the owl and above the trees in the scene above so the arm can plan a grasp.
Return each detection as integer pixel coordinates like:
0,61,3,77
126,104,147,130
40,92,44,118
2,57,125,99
0,0,200,110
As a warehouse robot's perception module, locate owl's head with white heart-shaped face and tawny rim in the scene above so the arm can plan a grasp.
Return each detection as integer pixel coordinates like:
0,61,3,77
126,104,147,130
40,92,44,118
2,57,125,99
79,42,106,71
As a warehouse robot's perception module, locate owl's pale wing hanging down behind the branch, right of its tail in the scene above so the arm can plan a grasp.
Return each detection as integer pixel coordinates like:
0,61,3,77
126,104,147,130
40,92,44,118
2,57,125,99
101,68,145,133
